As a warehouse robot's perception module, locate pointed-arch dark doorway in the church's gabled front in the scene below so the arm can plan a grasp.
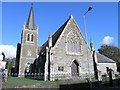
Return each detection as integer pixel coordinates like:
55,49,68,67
71,60,79,76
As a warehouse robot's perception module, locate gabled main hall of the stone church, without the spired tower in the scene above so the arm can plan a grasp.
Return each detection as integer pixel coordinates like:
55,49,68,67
38,16,94,80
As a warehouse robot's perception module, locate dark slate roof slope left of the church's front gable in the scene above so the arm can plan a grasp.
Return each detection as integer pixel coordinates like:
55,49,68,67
40,17,71,53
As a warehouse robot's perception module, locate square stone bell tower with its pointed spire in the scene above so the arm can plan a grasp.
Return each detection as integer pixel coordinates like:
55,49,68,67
18,4,38,77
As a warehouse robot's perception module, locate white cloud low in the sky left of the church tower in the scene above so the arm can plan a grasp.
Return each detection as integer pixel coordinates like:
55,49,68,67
0,45,16,58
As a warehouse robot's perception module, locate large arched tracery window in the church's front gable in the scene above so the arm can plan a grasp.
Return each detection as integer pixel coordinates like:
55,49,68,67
66,31,81,54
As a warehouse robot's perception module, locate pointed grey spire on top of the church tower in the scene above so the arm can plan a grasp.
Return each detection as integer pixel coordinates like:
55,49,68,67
26,3,34,29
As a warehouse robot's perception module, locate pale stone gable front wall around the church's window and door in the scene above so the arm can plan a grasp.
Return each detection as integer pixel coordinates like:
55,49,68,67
51,18,94,80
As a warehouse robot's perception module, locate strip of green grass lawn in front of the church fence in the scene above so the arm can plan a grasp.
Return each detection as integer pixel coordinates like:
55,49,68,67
5,76,71,86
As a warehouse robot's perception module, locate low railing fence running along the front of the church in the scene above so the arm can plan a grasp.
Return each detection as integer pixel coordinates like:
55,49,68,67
11,73,94,81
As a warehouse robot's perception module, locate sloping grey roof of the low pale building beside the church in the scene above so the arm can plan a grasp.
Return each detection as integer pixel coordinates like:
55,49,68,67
96,53,115,63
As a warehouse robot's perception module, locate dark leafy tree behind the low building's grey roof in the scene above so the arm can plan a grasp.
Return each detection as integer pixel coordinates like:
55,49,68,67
98,45,120,72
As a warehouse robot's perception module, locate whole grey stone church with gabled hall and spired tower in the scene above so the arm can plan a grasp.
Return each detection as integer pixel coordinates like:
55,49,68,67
15,5,116,81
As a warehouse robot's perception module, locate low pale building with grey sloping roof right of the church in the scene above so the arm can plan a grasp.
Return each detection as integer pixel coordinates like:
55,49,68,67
94,52,117,79
